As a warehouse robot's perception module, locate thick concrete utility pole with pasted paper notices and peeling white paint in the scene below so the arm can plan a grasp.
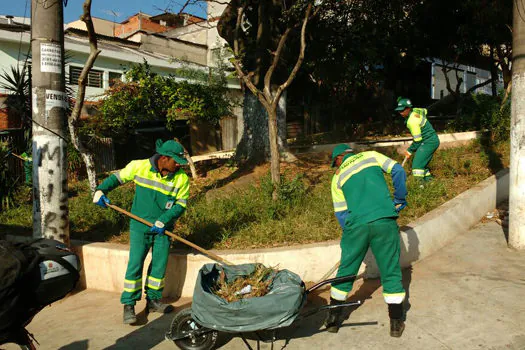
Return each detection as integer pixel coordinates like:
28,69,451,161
31,0,69,244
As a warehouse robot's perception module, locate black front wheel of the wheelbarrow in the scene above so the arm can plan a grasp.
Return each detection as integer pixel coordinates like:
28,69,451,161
166,308,219,350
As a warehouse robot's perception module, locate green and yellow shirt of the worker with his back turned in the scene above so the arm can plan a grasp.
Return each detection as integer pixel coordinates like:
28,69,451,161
332,151,398,229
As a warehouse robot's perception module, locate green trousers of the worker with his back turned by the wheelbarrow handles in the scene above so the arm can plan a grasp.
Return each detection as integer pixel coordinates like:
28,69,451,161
331,218,405,304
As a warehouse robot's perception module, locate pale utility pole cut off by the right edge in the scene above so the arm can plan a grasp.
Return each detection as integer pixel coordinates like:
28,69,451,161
509,0,525,249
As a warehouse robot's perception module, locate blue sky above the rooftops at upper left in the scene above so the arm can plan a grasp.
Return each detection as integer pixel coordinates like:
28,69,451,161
0,0,206,23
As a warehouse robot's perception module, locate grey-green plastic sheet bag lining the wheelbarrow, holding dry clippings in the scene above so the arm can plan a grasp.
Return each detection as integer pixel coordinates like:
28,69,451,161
191,264,306,332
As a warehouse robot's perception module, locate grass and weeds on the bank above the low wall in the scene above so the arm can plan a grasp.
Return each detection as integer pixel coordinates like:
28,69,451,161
0,141,509,249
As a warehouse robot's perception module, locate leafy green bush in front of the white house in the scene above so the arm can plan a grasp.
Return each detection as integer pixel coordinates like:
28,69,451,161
88,62,232,136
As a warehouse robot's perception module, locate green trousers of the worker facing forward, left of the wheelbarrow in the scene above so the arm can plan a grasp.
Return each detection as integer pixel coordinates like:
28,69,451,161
120,228,170,305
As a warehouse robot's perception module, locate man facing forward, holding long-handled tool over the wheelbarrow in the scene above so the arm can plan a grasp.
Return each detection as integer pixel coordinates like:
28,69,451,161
93,140,190,324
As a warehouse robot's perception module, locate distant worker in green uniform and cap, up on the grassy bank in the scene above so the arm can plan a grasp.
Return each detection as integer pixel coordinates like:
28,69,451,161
396,98,439,181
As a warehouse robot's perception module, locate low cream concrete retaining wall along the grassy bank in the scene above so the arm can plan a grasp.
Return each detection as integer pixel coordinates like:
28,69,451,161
70,170,509,297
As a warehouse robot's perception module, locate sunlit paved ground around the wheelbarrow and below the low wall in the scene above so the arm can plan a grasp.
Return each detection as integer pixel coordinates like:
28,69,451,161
7,222,525,350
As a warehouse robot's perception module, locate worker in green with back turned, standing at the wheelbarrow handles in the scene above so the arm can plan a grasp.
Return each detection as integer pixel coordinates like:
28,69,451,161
325,144,407,337
